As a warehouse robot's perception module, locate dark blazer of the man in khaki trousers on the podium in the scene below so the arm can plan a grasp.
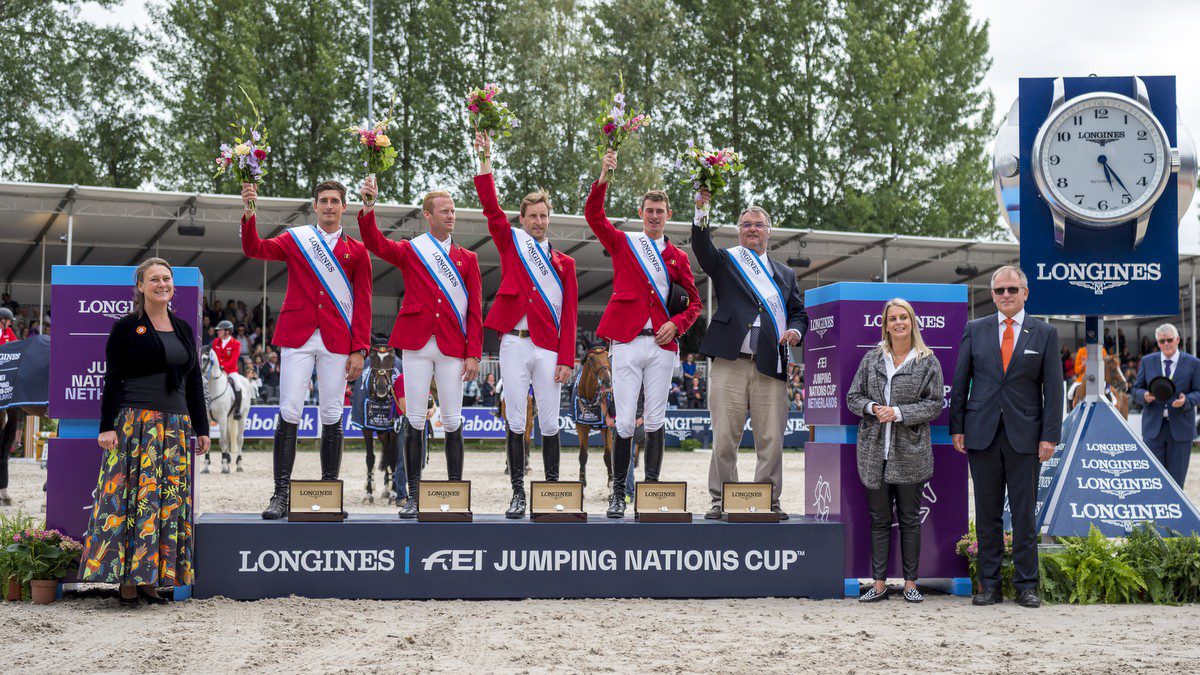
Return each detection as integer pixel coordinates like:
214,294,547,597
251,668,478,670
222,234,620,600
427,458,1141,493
691,225,809,380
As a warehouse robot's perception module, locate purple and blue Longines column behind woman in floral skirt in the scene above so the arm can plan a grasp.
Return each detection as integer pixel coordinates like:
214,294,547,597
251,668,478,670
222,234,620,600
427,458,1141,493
46,265,204,597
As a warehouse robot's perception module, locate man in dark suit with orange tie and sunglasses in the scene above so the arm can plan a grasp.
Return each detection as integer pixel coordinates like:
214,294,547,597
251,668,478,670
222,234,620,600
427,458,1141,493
950,265,1062,607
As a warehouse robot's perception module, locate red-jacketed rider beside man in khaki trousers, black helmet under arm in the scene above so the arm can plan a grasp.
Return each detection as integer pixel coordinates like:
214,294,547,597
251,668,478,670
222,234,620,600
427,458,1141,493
583,150,701,518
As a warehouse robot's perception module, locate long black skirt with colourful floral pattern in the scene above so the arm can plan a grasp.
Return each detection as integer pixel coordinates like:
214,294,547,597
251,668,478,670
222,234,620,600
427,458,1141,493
79,408,194,586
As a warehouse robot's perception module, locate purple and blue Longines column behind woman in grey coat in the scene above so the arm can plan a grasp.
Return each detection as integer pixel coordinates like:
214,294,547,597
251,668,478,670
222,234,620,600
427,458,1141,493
804,283,971,596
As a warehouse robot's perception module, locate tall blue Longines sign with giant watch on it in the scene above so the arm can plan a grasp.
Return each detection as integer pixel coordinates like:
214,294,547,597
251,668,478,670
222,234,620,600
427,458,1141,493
1019,77,1180,316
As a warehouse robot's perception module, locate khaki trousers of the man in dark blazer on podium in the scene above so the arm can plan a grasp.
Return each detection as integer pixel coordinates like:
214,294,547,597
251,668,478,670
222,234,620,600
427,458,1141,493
708,359,787,506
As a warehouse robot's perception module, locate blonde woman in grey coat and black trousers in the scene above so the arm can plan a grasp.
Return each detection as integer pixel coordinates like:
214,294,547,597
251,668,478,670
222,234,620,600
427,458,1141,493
846,298,943,602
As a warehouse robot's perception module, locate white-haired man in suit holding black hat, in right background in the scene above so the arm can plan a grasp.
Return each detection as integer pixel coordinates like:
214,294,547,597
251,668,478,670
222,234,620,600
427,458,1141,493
1133,323,1200,488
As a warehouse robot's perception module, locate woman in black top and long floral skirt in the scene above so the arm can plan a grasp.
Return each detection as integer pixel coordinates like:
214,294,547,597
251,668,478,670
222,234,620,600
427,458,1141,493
79,258,209,604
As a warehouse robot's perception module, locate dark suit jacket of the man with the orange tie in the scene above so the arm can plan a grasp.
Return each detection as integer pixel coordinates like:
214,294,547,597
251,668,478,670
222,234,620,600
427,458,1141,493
950,312,1062,453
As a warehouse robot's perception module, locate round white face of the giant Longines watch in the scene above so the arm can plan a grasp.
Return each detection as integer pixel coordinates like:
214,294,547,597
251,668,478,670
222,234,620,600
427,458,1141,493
1033,95,1170,225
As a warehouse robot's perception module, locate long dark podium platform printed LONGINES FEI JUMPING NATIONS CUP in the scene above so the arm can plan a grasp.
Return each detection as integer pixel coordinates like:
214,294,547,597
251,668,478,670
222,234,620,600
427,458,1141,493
193,514,845,599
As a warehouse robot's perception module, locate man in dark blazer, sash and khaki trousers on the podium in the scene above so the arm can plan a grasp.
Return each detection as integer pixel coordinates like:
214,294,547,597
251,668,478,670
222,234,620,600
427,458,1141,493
691,195,809,520
